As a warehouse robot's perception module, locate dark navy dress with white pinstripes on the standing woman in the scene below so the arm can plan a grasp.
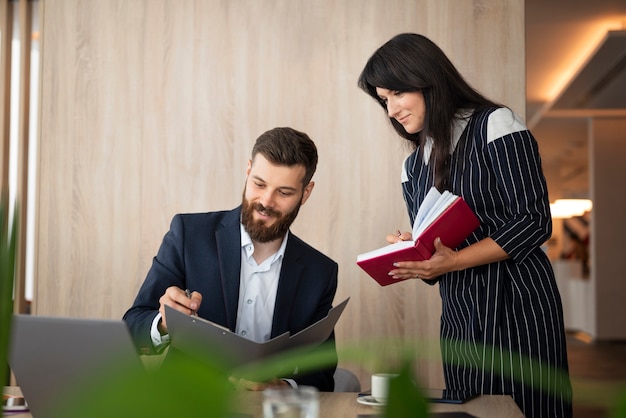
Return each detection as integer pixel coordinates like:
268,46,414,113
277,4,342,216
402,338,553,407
402,108,572,417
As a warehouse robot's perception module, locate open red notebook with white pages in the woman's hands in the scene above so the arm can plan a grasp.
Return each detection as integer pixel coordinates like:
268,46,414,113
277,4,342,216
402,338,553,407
356,188,480,286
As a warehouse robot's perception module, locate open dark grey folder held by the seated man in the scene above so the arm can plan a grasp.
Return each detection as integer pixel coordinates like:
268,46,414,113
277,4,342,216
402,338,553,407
165,298,350,367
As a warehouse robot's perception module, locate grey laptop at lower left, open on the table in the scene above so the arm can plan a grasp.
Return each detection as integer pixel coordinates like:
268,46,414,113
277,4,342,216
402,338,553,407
9,315,144,418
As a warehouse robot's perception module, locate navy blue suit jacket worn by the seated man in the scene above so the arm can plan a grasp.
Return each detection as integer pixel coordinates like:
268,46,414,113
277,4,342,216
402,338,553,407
124,207,338,391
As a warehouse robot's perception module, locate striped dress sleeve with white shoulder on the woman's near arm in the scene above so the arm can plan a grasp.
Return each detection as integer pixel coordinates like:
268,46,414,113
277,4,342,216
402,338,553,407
487,108,552,261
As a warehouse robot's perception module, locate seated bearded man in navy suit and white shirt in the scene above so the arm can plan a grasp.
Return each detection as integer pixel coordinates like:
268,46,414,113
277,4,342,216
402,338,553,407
124,128,338,391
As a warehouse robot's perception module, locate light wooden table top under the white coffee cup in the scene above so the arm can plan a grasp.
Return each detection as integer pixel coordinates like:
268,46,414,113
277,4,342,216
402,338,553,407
3,387,524,418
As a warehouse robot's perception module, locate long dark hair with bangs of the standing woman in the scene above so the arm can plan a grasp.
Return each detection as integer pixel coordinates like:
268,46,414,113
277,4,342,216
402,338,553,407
358,33,499,190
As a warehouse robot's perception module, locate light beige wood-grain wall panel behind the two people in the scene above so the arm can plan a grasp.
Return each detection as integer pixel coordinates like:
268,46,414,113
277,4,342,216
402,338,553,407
34,0,524,387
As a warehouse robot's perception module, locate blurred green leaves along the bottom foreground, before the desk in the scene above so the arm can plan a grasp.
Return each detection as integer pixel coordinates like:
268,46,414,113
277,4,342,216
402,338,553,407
35,340,626,418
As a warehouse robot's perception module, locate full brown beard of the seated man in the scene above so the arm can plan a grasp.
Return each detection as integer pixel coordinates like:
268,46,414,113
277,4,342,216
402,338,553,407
241,190,302,242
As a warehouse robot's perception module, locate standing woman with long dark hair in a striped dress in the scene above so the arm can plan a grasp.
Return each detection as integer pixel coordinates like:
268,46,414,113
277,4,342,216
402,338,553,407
359,33,572,418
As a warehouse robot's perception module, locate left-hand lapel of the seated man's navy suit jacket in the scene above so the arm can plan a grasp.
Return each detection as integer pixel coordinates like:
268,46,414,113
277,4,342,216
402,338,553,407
215,207,241,332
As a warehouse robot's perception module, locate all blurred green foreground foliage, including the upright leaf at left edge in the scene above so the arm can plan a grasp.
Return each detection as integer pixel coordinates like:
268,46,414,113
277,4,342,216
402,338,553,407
0,193,626,418
